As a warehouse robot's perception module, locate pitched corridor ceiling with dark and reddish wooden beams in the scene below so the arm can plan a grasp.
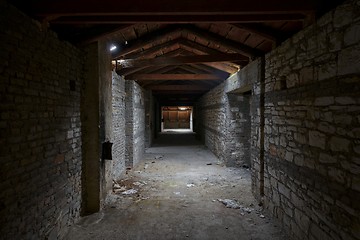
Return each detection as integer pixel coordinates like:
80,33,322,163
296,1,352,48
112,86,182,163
8,0,342,105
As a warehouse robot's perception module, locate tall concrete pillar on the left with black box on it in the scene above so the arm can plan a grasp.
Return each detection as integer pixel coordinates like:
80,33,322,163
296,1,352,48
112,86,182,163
81,42,112,215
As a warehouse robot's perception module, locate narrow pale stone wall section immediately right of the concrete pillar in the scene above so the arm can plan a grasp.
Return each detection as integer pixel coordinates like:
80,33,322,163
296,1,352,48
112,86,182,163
111,72,125,179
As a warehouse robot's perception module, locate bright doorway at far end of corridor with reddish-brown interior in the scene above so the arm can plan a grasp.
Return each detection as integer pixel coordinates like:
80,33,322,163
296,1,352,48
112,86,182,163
161,106,193,132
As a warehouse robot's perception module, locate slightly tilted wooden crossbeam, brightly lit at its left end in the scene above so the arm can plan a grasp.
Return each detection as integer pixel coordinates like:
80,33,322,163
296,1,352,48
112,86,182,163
118,54,250,68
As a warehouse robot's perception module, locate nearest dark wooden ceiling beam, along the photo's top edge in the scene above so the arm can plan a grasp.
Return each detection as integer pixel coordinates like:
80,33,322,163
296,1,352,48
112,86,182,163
23,0,318,16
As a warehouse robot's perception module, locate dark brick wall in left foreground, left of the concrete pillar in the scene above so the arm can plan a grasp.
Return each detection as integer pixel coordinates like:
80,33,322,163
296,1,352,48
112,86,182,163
0,1,83,239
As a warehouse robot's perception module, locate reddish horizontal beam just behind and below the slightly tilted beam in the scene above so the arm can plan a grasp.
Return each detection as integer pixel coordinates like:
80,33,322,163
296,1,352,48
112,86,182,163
127,73,224,81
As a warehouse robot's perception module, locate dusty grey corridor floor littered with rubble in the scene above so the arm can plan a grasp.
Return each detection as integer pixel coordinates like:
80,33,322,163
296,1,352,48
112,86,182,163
67,132,287,240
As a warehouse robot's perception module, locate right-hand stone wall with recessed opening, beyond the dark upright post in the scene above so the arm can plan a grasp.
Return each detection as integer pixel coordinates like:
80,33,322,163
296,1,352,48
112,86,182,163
195,60,260,167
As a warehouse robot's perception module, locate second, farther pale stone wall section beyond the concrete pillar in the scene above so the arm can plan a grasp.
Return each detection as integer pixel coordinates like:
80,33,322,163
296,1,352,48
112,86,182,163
125,80,146,167
